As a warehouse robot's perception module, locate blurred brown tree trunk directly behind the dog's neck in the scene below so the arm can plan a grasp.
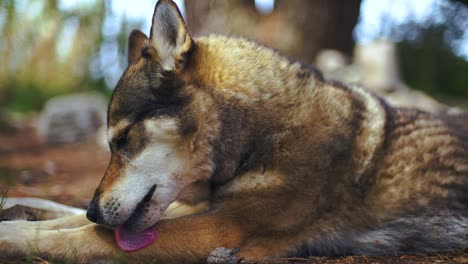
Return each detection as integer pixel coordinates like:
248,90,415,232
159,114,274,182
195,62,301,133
185,0,361,63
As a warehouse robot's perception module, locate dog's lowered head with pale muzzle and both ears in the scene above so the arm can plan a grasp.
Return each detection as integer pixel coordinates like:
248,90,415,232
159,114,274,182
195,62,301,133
87,0,216,230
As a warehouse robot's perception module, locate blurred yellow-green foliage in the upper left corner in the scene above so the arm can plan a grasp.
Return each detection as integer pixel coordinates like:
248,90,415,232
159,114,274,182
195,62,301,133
0,0,105,111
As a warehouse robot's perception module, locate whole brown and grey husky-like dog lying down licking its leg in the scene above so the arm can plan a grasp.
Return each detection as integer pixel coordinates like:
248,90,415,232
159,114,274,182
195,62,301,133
0,0,468,263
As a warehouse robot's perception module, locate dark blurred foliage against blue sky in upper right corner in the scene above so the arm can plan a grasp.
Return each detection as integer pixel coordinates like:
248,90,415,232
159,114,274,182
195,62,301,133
392,1,468,98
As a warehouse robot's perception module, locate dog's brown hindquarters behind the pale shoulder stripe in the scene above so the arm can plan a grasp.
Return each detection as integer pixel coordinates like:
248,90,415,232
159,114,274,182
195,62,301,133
352,108,468,254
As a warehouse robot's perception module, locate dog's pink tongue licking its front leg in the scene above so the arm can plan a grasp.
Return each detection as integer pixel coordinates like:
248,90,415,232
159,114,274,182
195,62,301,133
114,225,158,252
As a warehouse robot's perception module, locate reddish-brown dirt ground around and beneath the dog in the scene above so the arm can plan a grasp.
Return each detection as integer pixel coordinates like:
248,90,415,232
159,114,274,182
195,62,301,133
0,120,468,264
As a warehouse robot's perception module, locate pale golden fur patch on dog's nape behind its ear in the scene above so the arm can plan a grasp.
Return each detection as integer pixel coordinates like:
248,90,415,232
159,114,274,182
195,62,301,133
186,36,322,124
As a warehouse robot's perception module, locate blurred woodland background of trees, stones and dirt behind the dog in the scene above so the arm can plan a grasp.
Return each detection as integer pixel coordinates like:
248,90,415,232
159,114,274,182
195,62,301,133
0,0,468,207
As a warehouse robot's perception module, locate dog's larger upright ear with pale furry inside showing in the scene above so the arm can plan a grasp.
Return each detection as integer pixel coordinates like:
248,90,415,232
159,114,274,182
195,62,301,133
150,0,193,71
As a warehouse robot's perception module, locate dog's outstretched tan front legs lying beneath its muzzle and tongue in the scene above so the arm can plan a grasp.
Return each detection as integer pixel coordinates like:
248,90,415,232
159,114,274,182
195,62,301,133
0,209,244,263
